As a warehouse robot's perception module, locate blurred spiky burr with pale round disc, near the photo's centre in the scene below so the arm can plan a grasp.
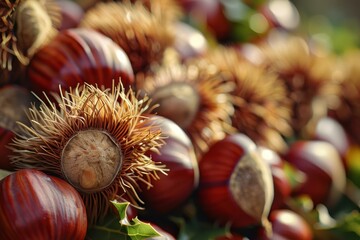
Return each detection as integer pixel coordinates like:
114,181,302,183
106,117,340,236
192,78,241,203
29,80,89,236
138,59,235,156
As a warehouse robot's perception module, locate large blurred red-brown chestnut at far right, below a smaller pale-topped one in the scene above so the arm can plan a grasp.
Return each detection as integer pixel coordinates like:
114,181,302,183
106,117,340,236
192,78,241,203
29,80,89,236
284,140,346,206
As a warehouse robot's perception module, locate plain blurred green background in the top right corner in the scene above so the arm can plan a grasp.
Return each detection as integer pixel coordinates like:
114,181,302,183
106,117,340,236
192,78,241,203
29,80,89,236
292,0,360,52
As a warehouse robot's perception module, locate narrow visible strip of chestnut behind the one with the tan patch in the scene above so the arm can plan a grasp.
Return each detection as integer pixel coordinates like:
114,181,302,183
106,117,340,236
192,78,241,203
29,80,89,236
257,146,291,209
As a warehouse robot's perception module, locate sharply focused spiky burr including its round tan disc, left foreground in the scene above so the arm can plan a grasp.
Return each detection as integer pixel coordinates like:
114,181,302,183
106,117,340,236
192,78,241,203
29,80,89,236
12,84,164,222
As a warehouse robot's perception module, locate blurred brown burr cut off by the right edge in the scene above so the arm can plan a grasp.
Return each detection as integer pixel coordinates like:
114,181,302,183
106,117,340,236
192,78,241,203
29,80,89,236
330,49,360,144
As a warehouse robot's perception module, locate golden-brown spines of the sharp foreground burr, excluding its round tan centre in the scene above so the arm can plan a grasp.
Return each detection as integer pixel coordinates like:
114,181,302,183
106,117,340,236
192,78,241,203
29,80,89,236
11,84,165,223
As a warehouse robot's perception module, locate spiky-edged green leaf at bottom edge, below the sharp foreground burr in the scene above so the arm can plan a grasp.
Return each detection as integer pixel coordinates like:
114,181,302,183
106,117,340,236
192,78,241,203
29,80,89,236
86,201,161,240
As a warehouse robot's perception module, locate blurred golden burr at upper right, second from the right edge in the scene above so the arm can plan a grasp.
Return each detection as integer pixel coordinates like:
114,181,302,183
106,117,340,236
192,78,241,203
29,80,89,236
261,36,339,134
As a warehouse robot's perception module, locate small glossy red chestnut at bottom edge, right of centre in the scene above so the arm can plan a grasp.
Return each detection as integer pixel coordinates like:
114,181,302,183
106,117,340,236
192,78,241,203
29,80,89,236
258,209,313,240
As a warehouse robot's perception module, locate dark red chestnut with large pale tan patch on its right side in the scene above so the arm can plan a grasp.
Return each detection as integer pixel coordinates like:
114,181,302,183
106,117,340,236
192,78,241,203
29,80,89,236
199,133,274,228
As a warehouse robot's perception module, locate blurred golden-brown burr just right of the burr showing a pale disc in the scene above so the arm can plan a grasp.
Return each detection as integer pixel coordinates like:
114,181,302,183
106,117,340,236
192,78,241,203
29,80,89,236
202,47,292,152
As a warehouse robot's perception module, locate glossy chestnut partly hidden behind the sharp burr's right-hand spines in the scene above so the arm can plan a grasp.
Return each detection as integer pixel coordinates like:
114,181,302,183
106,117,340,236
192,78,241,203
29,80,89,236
141,115,199,213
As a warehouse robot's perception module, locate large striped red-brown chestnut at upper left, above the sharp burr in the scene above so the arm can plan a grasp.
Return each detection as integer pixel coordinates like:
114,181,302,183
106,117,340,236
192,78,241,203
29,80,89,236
27,28,134,100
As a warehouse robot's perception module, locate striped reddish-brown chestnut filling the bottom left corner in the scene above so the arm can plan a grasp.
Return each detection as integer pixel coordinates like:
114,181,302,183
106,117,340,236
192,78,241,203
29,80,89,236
0,169,87,240
